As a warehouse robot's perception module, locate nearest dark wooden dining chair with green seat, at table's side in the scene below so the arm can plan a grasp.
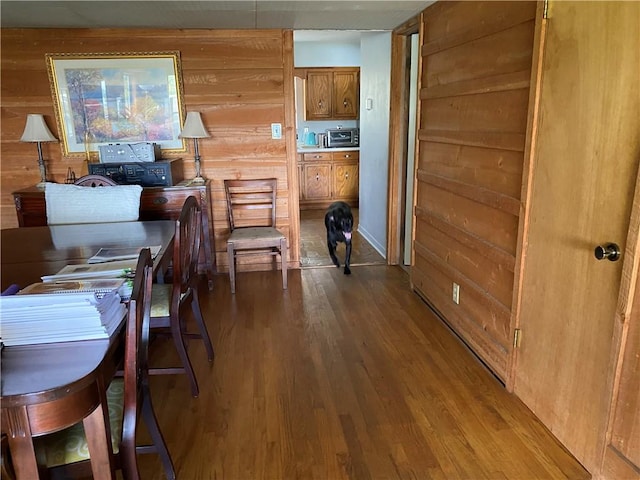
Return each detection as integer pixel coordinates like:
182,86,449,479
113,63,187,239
39,248,176,480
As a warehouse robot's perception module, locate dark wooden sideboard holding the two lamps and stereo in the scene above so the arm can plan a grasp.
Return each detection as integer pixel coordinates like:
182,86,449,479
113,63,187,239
13,182,216,289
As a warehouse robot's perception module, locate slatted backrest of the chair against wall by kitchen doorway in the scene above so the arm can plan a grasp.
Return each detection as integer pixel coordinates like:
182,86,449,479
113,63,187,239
224,178,278,231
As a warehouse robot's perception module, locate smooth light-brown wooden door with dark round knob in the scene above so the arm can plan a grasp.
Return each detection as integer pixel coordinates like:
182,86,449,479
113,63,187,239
513,1,640,472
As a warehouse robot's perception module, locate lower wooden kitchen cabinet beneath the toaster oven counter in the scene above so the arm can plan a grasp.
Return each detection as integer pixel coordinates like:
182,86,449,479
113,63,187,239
298,151,360,210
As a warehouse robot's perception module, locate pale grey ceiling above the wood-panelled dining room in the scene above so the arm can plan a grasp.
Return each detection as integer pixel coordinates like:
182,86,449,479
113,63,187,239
0,0,434,30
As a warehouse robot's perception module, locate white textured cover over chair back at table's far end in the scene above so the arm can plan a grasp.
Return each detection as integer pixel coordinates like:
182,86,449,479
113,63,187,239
44,183,142,225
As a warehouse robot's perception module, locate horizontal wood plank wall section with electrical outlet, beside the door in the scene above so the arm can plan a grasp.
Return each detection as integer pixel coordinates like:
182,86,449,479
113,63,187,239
411,2,536,381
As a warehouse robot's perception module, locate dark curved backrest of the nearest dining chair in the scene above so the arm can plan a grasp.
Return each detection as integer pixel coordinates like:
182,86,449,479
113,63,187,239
120,248,153,478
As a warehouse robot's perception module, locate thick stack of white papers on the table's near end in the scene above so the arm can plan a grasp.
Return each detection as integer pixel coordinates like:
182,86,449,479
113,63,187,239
0,290,126,346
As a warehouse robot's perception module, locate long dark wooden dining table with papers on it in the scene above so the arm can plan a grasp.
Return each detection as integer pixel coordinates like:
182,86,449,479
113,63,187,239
0,220,175,480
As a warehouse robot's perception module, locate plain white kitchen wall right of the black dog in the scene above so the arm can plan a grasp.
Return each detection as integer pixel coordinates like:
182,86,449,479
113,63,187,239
358,32,391,258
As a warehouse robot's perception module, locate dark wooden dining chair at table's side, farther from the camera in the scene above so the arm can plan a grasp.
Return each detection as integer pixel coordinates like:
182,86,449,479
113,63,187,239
150,196,214,397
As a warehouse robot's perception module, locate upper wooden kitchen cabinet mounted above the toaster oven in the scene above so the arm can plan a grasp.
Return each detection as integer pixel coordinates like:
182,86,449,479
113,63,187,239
305,67,360,120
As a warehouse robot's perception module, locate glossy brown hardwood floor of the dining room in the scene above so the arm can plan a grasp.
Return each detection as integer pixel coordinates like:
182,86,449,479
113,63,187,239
140,266,590,480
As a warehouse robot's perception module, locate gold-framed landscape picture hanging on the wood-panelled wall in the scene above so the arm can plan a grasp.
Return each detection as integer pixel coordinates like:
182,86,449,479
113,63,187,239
45,52,186,158
